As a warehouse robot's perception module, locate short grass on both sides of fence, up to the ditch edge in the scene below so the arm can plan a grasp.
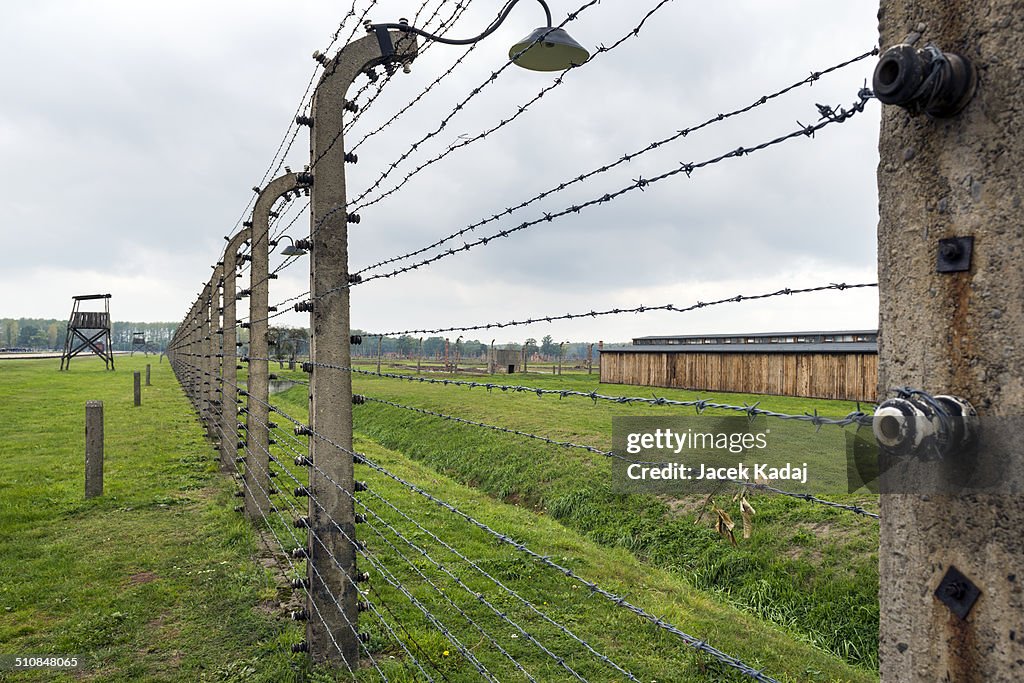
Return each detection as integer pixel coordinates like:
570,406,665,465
0,358,876,682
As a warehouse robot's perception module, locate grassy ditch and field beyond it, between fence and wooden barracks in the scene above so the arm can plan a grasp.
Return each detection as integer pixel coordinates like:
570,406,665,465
280,366,879,671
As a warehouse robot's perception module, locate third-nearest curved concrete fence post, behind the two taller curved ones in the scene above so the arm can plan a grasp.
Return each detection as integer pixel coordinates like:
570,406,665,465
220,227,251,473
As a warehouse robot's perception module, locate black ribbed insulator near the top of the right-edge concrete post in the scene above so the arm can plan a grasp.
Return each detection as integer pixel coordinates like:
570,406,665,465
871,44,978,119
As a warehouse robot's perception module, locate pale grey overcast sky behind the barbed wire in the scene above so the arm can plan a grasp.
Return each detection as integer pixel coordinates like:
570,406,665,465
0,0,879,343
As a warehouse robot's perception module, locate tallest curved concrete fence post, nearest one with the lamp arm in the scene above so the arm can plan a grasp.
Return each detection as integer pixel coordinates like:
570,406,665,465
306,32,416,669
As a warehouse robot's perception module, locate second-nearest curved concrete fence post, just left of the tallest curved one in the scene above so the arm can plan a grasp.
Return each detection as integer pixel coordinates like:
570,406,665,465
244,173,296,520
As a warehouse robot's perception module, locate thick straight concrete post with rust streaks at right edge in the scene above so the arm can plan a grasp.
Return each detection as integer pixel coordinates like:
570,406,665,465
878,0,1024,683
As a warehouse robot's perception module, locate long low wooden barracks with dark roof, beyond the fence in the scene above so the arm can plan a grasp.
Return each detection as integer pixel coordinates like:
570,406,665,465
601,330,879,400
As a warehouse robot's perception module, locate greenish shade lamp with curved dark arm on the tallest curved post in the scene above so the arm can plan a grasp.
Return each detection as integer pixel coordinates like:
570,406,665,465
366,0,590,71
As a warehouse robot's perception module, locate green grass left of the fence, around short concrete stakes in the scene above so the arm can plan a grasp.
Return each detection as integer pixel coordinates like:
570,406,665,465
0,356,298,681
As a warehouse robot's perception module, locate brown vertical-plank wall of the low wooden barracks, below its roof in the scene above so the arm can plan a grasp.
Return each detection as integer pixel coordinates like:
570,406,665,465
601,351,879,400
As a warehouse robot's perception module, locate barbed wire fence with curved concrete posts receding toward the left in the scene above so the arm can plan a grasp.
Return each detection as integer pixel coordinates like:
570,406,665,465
168,0,878,682
